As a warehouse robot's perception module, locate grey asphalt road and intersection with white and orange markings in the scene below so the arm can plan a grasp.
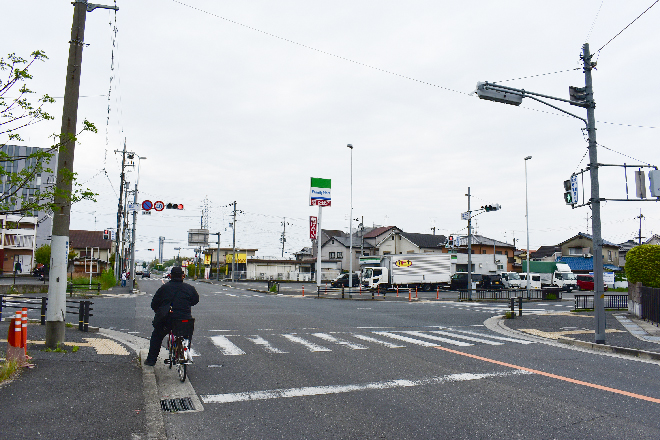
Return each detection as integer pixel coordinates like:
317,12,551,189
94,279,660,439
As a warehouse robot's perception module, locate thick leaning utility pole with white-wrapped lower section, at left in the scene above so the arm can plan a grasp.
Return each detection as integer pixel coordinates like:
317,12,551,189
46,0,118,348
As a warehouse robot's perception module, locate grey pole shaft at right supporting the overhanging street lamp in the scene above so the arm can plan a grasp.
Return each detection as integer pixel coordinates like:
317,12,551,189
582,43,605,344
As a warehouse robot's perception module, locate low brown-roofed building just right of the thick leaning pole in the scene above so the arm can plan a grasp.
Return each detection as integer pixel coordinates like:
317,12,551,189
69,230,115,276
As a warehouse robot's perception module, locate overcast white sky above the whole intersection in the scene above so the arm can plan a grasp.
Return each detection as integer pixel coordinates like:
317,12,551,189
0,0,660,258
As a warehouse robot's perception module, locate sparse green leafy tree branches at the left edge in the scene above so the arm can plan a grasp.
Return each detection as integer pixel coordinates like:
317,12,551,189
0,50,97,215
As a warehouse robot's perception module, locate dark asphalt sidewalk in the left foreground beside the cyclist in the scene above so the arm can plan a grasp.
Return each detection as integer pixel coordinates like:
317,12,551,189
0,289,148,440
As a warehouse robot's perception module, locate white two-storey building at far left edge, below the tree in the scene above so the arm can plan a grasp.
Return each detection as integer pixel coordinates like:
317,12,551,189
0,214,38,273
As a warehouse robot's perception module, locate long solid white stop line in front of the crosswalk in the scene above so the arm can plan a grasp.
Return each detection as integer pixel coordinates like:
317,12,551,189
200,370,533,403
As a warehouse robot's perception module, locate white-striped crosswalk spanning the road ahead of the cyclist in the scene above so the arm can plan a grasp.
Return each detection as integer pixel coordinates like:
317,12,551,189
202,327,534,356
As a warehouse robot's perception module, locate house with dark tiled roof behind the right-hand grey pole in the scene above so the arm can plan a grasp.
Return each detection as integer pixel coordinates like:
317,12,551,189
556,232,620,273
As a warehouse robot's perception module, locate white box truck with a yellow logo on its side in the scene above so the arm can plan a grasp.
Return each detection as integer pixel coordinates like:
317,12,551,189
362,253,451,292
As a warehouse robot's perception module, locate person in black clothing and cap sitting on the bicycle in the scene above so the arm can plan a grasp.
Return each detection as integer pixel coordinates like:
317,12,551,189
144,266,199,367
